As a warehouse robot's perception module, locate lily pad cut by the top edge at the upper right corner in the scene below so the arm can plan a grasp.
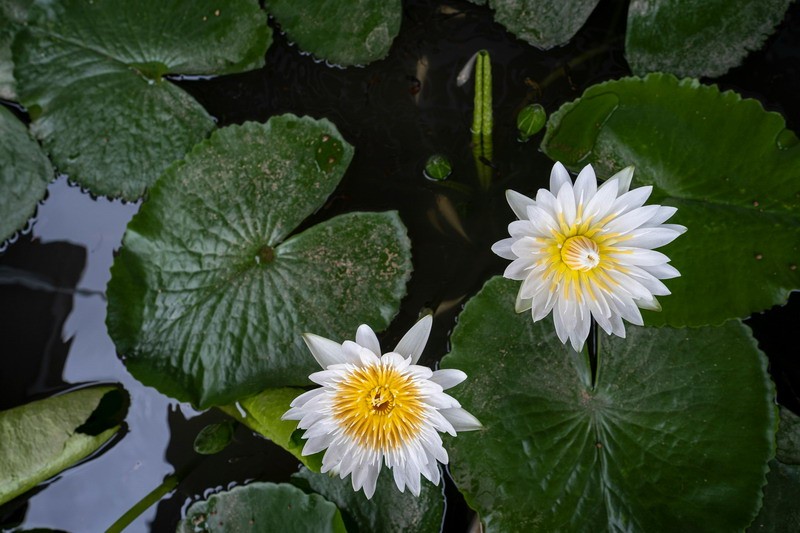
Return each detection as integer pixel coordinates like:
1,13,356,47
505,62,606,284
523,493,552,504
625,0,792,77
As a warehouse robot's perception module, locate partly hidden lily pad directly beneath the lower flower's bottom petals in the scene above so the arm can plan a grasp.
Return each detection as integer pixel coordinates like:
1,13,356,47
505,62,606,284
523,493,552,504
292,468,444,533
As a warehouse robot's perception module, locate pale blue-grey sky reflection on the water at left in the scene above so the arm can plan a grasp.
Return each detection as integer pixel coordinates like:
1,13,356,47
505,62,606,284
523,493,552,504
16,178,181,532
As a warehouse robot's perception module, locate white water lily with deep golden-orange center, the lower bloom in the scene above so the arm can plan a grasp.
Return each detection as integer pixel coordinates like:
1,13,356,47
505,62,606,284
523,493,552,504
283,316,481,498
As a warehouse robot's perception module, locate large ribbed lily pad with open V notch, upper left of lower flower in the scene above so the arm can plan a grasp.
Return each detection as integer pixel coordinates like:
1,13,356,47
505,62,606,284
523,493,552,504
107,115,411,408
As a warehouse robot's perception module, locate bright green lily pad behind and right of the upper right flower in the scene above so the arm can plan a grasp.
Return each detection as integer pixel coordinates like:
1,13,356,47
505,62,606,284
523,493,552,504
542,74,800,326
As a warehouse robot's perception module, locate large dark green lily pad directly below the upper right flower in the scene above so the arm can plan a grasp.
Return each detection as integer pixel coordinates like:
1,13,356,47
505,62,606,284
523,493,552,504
442,277,776,532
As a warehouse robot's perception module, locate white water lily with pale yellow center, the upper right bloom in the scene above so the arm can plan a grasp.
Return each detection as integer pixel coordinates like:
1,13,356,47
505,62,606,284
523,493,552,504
492,163,686,351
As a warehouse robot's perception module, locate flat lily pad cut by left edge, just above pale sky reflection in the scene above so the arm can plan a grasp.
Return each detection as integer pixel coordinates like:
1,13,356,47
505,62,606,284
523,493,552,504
0,106,54,243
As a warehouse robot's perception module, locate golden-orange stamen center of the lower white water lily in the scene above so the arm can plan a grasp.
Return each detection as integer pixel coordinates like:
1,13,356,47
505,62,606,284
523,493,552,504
333,364,424,451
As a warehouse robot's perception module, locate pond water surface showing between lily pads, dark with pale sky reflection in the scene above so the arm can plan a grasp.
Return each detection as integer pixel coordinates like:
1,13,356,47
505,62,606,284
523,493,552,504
0,0,800,532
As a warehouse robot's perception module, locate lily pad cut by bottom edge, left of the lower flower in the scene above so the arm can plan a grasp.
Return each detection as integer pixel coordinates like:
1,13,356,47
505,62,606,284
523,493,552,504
176,483,347,533
